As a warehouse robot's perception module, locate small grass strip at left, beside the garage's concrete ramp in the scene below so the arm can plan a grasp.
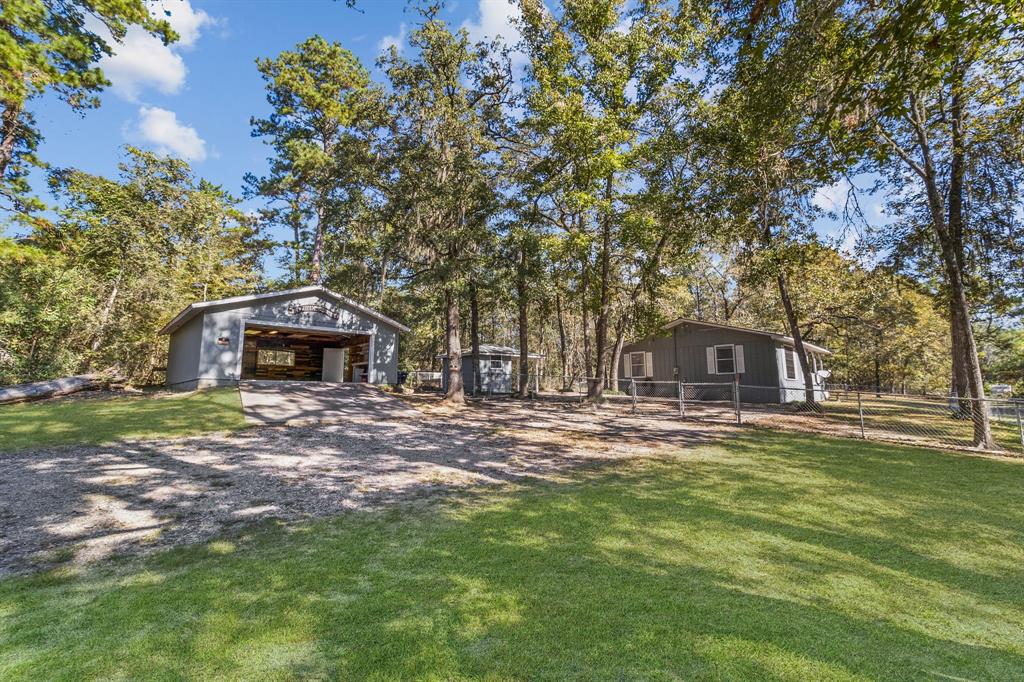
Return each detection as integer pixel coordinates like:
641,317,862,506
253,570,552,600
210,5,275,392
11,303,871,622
0,388,245,452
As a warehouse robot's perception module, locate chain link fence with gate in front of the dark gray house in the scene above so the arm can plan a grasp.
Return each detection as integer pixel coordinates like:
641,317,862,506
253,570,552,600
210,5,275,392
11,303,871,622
546,379,1024,455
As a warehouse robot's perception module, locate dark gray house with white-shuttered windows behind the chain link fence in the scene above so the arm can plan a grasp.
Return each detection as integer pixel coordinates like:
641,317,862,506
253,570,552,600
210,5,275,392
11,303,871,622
617,317,831,402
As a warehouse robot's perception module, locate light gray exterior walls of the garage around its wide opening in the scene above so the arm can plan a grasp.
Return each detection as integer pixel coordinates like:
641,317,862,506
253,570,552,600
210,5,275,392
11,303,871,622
167,294,398,387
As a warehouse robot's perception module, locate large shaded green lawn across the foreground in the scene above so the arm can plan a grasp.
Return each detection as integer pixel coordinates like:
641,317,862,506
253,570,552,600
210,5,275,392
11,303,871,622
0,430,1024,680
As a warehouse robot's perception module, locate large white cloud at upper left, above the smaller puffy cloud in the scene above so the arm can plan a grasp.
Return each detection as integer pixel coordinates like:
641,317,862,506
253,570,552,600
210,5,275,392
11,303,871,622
96,0,216,101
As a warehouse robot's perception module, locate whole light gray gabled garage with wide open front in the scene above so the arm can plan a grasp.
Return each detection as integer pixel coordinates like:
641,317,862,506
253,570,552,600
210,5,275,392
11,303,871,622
161,286,409,390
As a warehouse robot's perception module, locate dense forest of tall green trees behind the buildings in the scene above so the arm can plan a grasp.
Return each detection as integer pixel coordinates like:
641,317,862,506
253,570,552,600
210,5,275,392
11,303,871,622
0,0,1024,417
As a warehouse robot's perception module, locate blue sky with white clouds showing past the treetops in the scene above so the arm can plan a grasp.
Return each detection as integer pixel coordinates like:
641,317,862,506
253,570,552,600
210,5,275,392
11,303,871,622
16,0,872,269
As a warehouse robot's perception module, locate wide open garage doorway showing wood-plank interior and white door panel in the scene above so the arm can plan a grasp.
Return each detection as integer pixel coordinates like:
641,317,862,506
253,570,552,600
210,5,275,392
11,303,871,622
242,324,370,383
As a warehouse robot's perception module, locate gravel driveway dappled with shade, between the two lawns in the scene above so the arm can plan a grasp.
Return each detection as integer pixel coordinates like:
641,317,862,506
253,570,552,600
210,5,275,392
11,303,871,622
0,401,727,574
